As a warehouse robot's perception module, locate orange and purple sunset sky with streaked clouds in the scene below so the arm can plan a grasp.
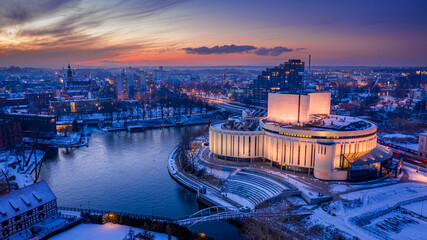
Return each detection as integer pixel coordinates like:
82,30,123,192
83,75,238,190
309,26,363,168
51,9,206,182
0,0,427,67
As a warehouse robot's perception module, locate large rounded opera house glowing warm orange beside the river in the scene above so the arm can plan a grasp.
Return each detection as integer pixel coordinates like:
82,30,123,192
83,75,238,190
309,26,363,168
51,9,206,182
209,92,392,181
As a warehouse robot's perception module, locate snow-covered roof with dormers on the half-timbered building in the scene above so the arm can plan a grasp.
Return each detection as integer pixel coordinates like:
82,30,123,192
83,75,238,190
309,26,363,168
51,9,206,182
0,181,56,222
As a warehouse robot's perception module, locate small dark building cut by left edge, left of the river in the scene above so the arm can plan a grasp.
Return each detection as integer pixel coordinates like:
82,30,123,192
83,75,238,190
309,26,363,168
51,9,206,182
0,119,22,149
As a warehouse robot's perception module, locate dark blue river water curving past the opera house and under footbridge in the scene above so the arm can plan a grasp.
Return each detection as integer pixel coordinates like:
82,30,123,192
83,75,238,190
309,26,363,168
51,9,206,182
40,126,243,239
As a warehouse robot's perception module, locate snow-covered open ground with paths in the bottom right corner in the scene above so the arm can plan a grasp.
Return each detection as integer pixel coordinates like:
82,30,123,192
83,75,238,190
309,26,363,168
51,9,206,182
310,166,427,240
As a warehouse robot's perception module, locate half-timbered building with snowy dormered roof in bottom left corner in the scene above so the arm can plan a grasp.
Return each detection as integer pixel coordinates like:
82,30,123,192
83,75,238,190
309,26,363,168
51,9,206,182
0,181,59,240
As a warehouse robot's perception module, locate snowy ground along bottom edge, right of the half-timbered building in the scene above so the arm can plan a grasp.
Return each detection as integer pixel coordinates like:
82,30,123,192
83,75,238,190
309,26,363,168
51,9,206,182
50,223,176,240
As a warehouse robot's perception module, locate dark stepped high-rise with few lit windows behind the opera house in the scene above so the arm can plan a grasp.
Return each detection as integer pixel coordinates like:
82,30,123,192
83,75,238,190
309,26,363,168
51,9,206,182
252,60,304,103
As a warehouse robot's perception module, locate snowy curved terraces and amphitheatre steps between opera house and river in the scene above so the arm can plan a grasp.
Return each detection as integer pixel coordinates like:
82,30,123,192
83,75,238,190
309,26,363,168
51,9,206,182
168,138,338,209
